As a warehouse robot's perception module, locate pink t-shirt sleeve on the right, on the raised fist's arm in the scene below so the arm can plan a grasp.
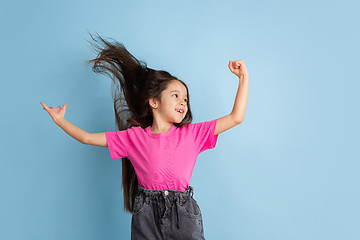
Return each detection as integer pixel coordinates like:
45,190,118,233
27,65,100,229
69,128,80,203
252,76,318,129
192,119,219,153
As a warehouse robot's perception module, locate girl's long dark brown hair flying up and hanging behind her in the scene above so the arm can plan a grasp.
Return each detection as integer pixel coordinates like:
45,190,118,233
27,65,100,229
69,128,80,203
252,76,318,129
86,33,192,213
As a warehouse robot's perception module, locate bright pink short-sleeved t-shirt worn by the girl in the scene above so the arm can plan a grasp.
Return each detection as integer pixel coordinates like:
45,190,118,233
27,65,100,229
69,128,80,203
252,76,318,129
105,119,219,191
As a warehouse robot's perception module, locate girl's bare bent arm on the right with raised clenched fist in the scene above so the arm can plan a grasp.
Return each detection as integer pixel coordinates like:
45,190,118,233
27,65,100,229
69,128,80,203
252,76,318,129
214,60,249,135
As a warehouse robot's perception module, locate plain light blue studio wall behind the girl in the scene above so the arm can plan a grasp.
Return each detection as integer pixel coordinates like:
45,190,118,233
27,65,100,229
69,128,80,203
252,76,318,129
0,0,360,240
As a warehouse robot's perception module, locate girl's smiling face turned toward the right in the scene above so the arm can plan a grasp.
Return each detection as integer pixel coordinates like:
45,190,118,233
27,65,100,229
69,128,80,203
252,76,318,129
151,80,188,123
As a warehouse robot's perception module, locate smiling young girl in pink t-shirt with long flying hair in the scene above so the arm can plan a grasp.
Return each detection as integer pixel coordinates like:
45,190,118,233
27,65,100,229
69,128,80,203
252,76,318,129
40,34,249,240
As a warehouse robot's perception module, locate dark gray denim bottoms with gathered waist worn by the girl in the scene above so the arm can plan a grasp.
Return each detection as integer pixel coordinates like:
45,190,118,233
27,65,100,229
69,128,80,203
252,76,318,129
131,185,205,240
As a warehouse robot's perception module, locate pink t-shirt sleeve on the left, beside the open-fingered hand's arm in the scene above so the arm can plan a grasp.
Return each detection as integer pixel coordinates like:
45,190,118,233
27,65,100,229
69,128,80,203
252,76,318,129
105,129,130,160
